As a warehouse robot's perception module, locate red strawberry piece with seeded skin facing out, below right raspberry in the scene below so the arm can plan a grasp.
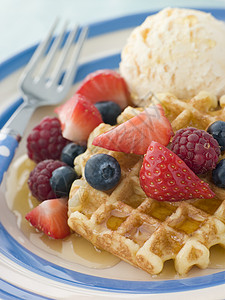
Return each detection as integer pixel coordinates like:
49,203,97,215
140,142,215,201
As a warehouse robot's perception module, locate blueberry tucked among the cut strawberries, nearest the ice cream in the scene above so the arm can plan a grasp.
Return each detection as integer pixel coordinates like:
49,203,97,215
95,101,121,125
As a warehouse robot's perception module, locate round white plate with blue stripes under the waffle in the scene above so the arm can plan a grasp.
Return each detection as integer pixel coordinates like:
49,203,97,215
0,9,225,299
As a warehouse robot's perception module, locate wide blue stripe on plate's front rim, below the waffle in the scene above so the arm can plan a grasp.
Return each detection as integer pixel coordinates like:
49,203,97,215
0,221,225,294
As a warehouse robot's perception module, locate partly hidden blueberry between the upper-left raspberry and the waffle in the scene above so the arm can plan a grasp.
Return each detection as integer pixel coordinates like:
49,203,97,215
60,143,86,168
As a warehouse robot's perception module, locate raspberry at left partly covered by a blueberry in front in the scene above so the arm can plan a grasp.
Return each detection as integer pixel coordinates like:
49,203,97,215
28,159,66,201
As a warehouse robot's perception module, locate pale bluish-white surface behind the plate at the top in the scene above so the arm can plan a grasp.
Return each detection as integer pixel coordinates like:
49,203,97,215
0,0,225,62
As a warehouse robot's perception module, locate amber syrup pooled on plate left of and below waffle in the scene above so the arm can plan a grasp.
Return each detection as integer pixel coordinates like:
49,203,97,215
6,155,120,268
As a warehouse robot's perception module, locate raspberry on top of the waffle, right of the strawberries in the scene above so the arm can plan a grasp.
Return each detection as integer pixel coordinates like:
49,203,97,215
171,127,220,174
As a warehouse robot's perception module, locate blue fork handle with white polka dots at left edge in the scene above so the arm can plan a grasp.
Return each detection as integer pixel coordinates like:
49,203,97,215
0,131,19,183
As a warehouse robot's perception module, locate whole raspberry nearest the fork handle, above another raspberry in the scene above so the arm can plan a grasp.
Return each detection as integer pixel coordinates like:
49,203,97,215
27,117,69,163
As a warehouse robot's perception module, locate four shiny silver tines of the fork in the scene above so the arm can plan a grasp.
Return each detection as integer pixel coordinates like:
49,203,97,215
25,19,88,88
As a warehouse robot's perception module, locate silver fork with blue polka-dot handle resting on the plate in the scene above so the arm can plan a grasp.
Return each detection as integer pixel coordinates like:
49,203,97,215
0,20,88,183
